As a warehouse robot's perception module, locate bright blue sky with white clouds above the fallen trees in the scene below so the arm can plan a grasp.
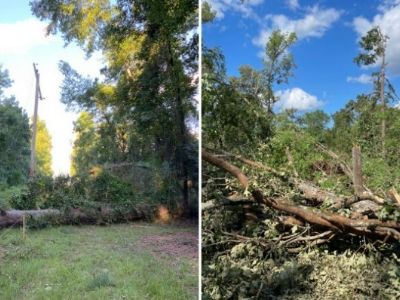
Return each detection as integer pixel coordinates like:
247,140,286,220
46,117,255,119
203,0,400,113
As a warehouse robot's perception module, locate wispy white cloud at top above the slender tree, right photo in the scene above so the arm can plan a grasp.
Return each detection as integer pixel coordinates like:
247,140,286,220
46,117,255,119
253,5,341,48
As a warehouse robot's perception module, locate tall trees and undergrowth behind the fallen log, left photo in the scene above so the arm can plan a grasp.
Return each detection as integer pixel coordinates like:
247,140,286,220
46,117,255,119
0,0,198,217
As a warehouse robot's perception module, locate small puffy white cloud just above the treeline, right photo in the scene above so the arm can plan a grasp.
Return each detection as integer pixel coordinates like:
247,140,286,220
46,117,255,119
276,87,323,111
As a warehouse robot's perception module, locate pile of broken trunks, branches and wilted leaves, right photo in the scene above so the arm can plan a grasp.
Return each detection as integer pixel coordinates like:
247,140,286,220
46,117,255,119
202,145,400,299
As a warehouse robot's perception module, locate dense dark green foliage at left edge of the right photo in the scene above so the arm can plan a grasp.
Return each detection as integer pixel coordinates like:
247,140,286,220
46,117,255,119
202,49,271,148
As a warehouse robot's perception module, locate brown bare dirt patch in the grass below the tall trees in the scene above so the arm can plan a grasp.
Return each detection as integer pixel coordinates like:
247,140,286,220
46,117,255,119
140,231,198,260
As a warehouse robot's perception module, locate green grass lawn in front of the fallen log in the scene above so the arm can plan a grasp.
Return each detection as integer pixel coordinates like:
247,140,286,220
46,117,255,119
0,223,198,300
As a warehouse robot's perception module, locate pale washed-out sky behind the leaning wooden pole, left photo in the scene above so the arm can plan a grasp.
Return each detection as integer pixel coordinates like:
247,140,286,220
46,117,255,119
0,0,102,174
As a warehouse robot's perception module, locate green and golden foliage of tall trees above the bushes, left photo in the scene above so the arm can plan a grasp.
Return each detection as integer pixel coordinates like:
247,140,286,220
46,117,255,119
31,0,198,216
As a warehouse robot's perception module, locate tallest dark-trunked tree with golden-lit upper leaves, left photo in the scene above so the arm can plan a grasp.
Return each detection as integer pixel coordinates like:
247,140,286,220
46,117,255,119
31,0,198,213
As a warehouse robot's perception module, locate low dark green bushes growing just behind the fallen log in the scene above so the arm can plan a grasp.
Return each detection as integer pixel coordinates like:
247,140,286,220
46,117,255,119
9,172,144,209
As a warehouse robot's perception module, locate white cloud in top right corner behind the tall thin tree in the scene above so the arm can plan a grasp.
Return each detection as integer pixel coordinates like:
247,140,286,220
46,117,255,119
353,0,400,75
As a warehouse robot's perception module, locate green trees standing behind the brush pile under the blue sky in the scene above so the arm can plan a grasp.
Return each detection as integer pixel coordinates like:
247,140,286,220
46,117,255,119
202,20,400,192
